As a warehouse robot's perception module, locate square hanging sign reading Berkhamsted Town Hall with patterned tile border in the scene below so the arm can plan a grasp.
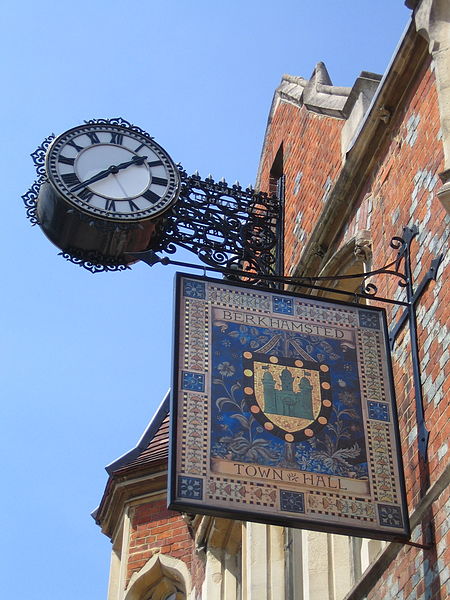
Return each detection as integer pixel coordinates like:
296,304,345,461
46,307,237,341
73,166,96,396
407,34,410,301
169,274,409,539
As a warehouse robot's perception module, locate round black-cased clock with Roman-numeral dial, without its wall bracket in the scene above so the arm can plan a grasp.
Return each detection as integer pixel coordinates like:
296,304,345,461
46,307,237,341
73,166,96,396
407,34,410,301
36,119,181,265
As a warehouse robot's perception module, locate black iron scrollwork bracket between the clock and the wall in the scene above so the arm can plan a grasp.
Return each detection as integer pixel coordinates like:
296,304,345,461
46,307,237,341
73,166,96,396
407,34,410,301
152,167,280,283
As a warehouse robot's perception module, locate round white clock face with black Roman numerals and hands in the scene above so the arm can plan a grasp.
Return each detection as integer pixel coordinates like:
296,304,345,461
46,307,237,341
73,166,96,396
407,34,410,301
46,123,180,222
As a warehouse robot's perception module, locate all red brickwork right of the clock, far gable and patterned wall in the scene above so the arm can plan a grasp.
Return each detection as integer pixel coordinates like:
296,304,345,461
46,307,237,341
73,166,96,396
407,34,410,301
261,55,450,600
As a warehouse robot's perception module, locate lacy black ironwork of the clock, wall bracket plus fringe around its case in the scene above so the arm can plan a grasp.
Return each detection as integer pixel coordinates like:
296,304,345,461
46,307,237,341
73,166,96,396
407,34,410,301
22,156,283,275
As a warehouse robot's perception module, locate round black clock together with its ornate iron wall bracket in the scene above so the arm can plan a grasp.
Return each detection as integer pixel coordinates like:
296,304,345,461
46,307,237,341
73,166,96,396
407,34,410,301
23,119,282,275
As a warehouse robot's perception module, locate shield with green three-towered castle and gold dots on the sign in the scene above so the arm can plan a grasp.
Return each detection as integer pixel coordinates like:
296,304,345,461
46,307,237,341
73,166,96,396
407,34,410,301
243,352,332,442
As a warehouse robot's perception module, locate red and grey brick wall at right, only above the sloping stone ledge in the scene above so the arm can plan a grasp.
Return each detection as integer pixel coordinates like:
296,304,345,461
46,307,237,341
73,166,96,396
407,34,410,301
341,65,450,509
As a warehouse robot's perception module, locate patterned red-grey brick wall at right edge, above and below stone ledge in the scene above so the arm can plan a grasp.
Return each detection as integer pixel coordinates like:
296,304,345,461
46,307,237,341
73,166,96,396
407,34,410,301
342,65,450,600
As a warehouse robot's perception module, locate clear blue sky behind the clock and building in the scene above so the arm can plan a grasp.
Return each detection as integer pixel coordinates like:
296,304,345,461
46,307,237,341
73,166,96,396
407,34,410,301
0,0,410,600
